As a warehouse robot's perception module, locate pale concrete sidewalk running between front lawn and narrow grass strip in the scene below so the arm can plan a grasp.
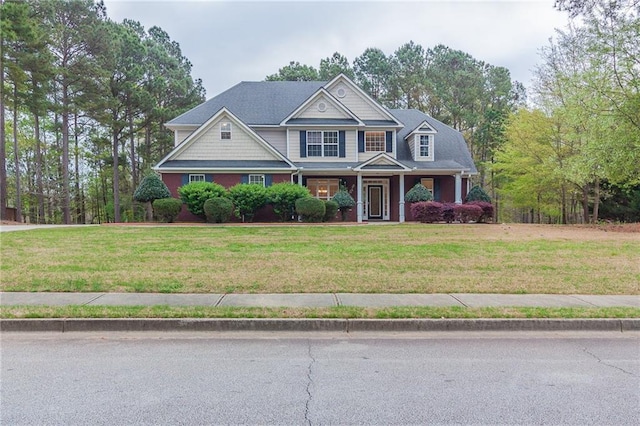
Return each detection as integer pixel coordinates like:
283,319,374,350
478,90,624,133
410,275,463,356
0,292,640,308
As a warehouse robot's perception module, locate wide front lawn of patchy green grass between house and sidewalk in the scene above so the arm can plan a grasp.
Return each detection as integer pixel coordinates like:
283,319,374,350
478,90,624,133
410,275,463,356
0,224,640,295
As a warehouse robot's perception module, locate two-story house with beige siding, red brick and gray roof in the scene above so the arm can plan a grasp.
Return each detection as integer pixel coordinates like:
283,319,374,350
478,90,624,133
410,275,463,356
154,74,477,222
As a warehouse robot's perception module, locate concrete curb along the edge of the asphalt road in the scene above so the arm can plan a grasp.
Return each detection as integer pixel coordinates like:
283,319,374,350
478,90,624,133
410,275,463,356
0,318,640,333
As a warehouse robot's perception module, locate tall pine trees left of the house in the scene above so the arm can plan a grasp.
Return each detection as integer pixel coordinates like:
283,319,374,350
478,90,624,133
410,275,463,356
0,0,205,223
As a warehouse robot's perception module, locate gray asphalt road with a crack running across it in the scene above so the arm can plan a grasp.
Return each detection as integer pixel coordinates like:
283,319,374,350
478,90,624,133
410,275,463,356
0,332,640,425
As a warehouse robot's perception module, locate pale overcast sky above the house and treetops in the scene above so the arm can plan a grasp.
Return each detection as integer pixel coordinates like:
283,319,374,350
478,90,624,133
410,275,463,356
105,0,568,99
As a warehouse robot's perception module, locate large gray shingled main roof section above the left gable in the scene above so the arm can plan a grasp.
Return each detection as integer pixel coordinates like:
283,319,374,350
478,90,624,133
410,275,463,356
167,81,327,126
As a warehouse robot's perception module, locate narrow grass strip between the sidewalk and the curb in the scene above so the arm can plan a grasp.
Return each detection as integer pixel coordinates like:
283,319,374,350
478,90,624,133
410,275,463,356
0,305,640,319
